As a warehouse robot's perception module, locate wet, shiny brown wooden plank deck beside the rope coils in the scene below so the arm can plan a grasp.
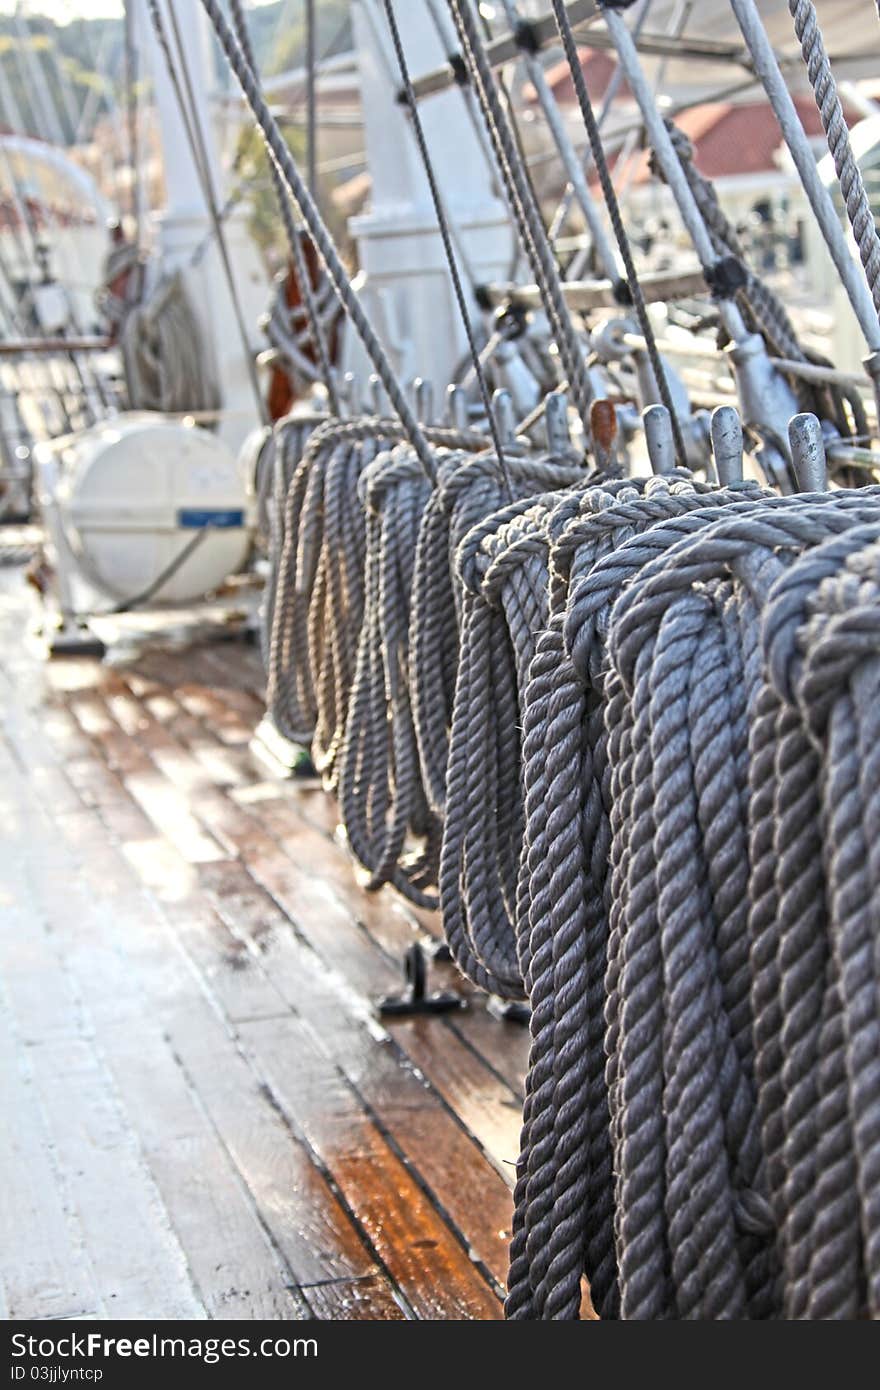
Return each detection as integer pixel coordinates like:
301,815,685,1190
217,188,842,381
0,566,528,1319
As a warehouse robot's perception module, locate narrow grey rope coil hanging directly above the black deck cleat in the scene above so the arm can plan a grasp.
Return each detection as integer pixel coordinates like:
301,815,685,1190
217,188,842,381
339,448,582,908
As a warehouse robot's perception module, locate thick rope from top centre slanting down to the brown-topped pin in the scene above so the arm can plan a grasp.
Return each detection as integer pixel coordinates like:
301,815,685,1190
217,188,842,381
449,0,594,436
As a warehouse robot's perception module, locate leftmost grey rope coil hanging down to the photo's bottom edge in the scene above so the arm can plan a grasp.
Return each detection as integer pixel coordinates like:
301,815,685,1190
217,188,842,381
507,477,755,1318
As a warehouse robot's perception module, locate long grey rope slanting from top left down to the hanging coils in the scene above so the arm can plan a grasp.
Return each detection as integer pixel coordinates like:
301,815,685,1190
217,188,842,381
202,0,437,484
